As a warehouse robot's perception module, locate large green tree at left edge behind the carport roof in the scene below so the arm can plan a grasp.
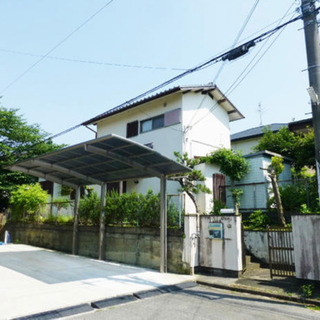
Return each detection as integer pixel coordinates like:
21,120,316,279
0,106,63,211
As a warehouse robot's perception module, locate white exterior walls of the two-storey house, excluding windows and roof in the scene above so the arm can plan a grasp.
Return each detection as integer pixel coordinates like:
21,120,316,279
97,92,230,213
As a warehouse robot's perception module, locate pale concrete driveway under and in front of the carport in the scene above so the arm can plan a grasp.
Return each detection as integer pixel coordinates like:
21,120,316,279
0,244,193,319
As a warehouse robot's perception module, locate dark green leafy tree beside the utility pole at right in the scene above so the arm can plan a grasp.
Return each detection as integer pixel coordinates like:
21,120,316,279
253,127,315,171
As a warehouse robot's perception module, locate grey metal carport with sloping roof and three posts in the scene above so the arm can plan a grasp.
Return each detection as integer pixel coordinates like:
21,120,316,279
7,134,190,272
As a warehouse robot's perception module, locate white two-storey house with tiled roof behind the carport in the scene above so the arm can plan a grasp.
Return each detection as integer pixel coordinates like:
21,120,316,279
83,85,243,212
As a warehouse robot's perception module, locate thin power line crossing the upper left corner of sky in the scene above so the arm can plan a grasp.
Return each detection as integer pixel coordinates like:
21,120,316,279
2,0,114,93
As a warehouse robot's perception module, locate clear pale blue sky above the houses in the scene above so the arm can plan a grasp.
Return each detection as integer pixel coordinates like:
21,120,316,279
0,0,311,144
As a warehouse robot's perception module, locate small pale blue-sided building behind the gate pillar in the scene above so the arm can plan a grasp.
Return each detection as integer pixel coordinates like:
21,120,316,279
226,151,291,212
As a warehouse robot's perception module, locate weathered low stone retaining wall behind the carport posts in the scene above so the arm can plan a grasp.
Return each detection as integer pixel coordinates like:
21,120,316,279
0,223,190,273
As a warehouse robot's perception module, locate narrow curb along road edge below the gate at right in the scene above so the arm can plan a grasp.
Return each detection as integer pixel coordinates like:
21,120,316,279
197,280,320,306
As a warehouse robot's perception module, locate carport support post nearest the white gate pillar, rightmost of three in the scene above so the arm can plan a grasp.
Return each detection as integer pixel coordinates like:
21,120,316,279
160,175,168,273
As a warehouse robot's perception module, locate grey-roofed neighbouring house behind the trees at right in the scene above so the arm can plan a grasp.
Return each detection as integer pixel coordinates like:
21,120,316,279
231,119,312,155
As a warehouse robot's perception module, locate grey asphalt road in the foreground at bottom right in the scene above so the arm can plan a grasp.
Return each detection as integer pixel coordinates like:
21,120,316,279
64,286,320,320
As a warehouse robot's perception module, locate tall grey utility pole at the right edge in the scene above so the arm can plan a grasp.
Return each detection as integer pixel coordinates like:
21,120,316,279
301,0,320,205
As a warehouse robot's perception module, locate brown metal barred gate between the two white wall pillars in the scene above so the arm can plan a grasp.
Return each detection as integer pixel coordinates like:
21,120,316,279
267,227,295,279
